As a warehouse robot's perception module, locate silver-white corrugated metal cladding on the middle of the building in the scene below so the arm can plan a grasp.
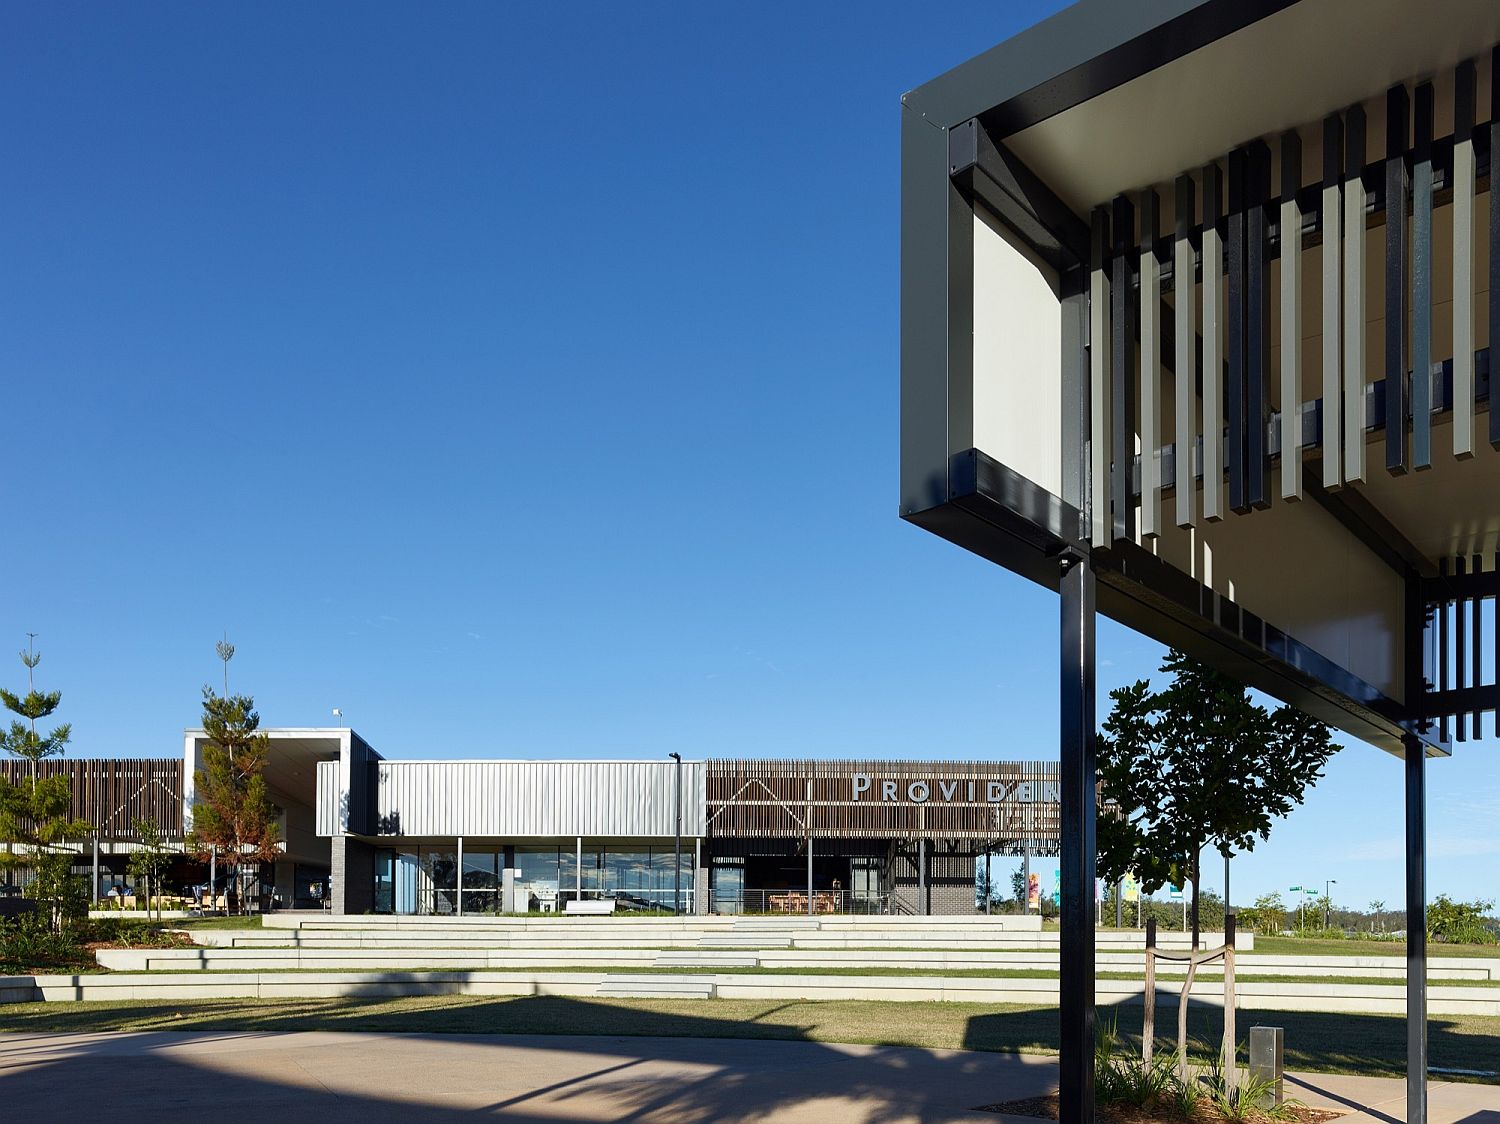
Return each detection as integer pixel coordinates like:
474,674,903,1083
372,761,704,839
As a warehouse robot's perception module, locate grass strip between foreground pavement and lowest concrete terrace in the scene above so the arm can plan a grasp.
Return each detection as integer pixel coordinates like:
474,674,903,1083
0,996,1500,1082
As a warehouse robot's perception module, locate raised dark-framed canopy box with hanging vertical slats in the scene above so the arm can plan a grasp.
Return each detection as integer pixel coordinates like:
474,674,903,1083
902,0,1500,753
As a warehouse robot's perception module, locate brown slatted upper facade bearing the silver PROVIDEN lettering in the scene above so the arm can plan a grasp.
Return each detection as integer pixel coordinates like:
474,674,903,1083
707,761,1059,843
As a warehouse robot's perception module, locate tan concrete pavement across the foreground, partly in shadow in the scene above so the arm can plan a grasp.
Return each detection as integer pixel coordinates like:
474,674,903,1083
0,1031,1500,1124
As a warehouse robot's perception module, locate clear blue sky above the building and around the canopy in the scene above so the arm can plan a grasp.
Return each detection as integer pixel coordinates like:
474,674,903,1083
0,3,1500,903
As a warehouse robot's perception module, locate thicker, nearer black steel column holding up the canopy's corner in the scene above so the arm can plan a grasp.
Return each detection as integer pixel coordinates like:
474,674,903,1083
1059,555,1098,1124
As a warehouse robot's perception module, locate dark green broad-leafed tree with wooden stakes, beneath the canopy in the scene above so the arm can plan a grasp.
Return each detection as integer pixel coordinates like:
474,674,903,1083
1098,651,1337,947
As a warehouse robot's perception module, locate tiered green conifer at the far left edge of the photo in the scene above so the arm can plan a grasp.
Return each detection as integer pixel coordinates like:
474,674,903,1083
0,644,93,930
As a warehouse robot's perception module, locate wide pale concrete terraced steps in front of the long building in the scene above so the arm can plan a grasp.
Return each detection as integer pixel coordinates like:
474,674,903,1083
11,914,1500,1014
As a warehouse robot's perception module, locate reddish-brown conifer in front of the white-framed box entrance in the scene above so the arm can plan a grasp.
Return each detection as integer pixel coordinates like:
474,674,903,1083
189,687,279,909
